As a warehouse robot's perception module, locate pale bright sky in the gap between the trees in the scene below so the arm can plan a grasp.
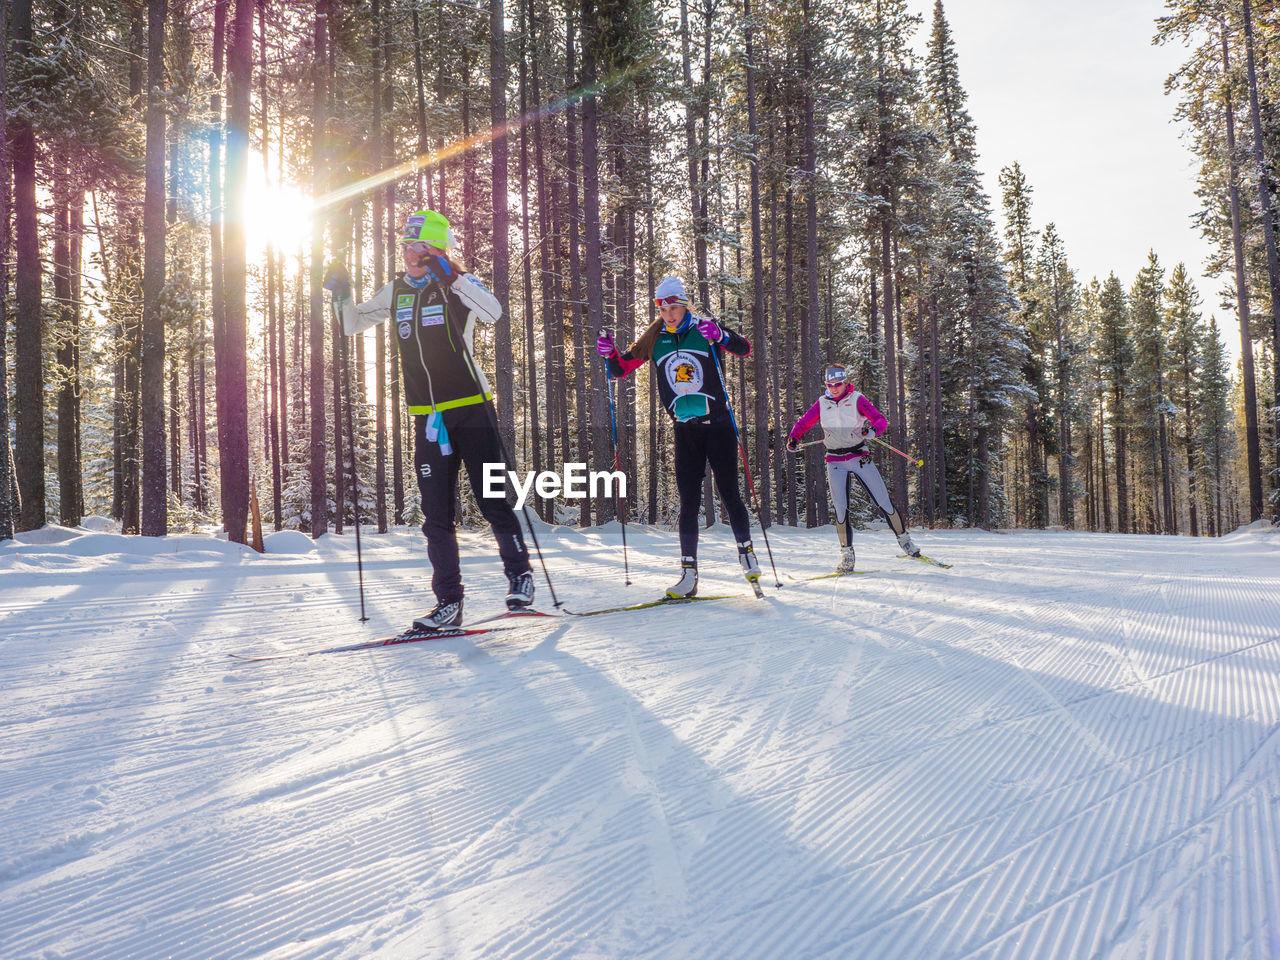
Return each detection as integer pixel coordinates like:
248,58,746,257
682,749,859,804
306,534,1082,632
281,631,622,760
910,0,1240,357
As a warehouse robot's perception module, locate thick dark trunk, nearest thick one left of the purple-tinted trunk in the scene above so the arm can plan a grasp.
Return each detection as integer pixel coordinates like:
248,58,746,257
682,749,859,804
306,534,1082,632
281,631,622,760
142,0,168,536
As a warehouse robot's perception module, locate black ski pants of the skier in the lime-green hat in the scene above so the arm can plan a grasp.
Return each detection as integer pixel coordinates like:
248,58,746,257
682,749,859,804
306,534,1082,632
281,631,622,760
413,402,529,603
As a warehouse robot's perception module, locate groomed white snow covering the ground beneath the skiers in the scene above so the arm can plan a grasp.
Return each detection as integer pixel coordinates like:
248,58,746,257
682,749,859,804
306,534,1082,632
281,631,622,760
0,527,1280,960
